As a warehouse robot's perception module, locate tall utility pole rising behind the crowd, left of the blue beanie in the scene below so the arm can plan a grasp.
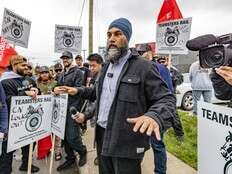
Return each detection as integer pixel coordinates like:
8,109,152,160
89,0,93,54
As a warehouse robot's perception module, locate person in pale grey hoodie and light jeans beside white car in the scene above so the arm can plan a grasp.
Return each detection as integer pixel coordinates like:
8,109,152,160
189,61,213,115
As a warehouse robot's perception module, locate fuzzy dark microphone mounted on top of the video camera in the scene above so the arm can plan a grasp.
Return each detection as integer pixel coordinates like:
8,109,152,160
186,34,218,51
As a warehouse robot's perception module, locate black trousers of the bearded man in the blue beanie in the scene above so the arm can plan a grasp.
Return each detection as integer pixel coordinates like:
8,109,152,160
96,126,142,174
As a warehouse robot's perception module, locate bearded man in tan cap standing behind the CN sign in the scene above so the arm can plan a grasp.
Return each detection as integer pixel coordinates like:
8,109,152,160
0,55,39,174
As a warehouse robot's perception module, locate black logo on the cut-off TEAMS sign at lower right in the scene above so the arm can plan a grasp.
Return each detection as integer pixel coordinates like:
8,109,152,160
220,131,232,174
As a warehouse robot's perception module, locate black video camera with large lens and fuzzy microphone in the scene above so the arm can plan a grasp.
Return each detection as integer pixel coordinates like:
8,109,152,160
186,33,232,68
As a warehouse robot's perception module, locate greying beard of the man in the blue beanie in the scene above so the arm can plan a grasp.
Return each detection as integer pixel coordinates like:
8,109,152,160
105,47,128,64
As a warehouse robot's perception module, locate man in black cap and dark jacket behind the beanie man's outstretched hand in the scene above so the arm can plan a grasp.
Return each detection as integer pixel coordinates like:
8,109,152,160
57,51,87,171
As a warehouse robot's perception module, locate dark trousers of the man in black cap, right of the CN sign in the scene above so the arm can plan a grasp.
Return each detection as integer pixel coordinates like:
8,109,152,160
64,115,87,160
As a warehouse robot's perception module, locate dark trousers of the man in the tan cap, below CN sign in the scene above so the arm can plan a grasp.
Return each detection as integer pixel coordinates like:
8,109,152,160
0,141,32,174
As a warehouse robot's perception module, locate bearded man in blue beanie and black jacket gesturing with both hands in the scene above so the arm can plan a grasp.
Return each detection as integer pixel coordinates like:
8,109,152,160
55,18,175,174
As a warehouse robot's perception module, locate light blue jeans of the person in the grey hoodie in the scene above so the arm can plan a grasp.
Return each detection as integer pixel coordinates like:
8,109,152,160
192,90,212,115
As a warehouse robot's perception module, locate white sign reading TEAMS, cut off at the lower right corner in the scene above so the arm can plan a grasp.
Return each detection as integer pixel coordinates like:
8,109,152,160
198,102,232,174
